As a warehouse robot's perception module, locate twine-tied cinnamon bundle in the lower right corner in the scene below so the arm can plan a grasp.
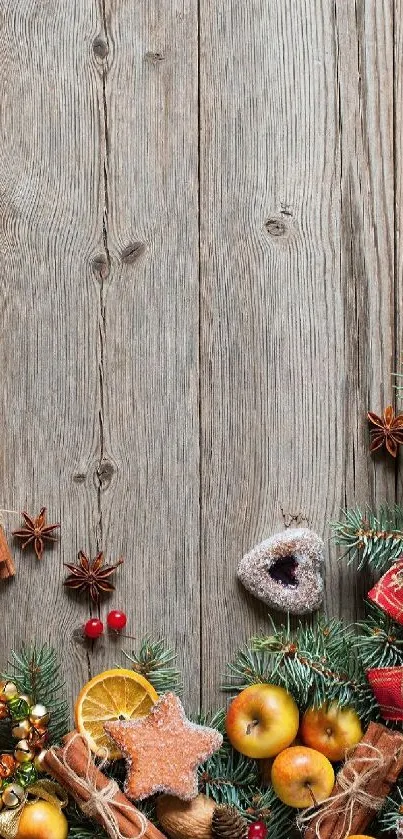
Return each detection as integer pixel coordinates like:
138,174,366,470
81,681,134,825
304,722,403,839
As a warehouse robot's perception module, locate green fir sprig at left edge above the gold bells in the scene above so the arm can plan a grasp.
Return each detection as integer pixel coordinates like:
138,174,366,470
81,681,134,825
4,645,69,743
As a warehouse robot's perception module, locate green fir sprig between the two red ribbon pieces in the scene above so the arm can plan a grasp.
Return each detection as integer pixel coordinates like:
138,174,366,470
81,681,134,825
354,604,403,670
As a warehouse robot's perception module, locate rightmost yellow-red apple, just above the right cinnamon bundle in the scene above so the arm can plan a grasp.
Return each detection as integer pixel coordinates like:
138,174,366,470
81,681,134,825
299,702,362,760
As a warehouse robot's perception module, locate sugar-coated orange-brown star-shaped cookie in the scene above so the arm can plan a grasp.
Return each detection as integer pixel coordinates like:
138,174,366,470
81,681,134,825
104,693,222,801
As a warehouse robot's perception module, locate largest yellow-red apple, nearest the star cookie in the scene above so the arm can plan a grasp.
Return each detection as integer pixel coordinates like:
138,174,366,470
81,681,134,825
226,684,299,758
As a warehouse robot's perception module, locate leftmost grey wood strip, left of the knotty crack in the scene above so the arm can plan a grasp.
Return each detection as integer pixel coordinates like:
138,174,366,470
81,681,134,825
0,0,103,712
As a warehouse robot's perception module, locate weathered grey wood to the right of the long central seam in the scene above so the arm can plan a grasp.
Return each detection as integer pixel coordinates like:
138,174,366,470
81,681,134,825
200,0,394,703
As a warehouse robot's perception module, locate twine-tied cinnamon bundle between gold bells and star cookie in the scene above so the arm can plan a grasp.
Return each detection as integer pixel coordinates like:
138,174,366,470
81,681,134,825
44,731,166,839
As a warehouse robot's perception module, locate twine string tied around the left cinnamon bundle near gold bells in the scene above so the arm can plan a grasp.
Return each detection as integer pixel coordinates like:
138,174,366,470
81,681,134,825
53,732,147,839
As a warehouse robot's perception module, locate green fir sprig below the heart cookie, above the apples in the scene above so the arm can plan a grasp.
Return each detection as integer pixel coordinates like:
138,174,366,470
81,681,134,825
225,619,376,722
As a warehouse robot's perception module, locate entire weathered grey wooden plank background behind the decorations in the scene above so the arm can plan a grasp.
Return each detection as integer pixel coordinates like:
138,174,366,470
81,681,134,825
0,0,403,707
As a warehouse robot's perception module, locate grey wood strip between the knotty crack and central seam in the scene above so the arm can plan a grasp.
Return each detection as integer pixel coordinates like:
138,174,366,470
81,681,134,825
87,0,200,708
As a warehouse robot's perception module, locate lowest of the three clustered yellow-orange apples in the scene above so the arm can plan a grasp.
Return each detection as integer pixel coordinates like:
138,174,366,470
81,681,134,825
271,746,334,807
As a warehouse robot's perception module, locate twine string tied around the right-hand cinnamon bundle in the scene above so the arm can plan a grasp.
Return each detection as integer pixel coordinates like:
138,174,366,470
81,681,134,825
297,743,390,839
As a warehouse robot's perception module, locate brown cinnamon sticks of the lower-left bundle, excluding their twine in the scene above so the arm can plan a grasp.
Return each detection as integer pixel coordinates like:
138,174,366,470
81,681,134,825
44,731,166,839
